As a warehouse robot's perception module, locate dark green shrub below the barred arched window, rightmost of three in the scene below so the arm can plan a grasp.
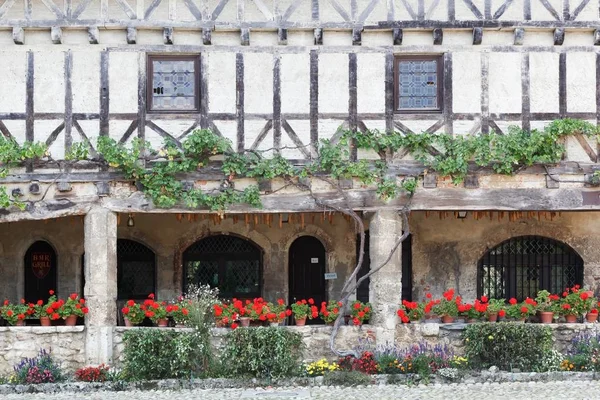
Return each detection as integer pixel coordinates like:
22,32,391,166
463,323,552,371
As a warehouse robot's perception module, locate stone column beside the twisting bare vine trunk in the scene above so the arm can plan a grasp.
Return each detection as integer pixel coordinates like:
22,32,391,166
369,210,402,343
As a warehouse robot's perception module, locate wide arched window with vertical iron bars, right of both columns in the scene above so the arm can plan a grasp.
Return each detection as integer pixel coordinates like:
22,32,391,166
478,236,583,301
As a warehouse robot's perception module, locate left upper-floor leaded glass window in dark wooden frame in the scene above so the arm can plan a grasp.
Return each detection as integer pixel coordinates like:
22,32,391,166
148,56,200,112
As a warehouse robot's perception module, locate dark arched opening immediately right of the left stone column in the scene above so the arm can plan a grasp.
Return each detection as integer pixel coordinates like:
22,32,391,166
117,239,156,300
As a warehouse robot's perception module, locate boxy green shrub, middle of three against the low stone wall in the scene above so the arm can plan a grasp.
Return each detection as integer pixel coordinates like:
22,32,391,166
222,327,303,378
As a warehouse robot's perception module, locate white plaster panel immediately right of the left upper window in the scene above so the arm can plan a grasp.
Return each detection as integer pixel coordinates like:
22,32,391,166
209,53,237,113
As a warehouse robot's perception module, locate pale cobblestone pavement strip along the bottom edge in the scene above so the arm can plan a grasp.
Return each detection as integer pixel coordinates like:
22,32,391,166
0,381,600,400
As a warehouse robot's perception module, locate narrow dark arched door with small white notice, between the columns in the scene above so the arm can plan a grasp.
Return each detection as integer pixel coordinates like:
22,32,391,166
289,236,327,323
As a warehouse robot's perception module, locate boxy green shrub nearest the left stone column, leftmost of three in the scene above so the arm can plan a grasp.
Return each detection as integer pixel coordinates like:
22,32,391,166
123,328,206,380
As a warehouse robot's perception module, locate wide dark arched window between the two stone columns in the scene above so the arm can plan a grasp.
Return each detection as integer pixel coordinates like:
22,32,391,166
183,235,262,299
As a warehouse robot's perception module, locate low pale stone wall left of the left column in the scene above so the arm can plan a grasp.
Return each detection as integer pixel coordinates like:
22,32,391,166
0,326,86,376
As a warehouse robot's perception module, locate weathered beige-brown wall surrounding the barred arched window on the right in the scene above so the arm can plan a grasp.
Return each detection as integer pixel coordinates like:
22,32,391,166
410,211,600,301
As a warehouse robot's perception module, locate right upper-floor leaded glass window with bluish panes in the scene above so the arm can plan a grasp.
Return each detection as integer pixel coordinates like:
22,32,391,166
394,56,443,112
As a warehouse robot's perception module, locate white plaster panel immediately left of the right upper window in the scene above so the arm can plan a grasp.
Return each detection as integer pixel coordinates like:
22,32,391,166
357,53,385,113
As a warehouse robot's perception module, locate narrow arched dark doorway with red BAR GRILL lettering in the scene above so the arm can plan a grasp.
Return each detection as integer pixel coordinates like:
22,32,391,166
24,240,58,303
